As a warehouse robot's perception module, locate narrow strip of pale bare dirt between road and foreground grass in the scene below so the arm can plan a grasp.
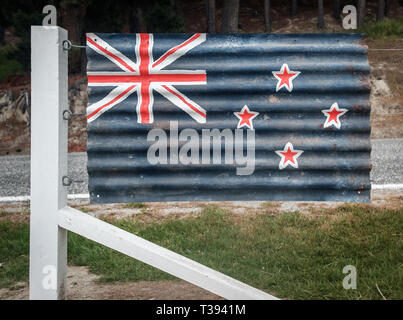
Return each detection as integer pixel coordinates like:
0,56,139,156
0,190,403,223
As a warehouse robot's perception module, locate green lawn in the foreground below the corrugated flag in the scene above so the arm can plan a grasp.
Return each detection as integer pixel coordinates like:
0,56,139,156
0,205,403,299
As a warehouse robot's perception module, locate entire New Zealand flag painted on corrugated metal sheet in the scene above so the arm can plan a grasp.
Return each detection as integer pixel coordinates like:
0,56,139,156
87,33,371,203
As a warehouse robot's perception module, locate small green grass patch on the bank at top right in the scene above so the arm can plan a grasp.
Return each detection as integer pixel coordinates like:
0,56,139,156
360,18,403,39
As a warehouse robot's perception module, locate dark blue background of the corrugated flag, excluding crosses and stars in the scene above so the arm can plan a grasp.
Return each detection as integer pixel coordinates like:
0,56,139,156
87,34,371,203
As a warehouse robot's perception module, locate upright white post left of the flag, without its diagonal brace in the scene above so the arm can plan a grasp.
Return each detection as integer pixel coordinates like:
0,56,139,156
29,26,68,299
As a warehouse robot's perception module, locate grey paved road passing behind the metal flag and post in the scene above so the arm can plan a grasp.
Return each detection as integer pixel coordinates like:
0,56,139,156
0,139,403,197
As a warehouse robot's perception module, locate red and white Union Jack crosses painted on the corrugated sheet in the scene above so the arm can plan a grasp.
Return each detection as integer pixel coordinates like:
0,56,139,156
87,33,207,124
